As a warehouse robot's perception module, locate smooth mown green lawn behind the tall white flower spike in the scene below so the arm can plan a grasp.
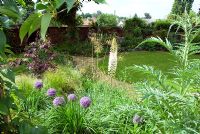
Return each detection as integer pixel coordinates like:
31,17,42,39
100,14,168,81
99,51,200,83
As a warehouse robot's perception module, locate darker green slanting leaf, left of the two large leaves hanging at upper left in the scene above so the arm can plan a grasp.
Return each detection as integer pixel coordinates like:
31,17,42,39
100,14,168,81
19,13,40,42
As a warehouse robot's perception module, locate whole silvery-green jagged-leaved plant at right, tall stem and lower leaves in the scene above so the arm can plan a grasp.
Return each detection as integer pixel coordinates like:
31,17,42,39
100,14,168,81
125,13,200,133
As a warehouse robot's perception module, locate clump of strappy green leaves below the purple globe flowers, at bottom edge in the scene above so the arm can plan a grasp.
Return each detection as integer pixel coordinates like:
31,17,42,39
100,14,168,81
46,101,89,134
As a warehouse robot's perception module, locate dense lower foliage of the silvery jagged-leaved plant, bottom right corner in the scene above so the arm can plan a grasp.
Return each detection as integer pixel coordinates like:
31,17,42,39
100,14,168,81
129,66,200,133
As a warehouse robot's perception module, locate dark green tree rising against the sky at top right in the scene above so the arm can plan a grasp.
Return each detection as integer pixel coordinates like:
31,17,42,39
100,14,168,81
171,0,194,15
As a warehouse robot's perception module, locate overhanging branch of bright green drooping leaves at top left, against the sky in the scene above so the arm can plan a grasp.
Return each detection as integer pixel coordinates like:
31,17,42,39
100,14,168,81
19,0,105,42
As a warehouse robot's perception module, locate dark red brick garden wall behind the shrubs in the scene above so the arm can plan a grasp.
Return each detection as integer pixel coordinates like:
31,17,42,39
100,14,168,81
6,26,123,52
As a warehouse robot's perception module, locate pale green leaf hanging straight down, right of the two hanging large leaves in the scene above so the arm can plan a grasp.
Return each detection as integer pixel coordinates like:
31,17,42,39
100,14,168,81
40,13,52,39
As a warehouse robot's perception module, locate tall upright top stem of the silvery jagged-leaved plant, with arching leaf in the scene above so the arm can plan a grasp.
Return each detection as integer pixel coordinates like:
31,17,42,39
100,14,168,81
141,13,200,68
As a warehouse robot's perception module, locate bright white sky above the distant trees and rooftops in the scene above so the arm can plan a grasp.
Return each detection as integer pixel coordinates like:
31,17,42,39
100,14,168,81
81,0,200,19
